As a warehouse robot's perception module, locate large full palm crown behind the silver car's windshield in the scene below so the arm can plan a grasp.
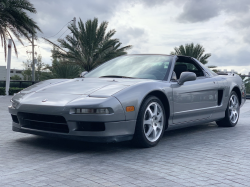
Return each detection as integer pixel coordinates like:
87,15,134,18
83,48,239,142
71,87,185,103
44,18,132,71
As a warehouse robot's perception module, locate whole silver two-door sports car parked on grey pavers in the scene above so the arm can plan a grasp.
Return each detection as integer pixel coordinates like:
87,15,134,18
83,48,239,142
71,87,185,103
9,55,246,147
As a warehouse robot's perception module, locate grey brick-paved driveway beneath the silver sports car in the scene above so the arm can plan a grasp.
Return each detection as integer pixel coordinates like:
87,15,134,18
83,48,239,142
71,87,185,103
0,97,250,187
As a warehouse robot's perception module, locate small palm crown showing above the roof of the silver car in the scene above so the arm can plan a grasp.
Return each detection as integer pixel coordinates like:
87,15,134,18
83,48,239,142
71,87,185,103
170,43,211,64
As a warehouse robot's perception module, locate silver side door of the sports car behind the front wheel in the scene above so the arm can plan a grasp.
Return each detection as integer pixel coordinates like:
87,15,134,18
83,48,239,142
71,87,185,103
171,57,218,124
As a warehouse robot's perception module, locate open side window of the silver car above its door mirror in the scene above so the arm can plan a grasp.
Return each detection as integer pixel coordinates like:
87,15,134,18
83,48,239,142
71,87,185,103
174,57,205,79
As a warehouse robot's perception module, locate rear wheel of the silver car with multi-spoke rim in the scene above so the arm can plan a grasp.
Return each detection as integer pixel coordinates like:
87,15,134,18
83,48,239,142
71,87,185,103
216,91,240,127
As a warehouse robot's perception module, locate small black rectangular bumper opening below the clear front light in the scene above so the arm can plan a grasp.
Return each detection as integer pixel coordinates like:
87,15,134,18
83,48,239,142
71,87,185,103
76,121,105,131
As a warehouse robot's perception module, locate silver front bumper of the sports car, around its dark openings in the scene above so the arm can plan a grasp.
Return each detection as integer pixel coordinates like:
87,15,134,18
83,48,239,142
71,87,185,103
9,97,136,142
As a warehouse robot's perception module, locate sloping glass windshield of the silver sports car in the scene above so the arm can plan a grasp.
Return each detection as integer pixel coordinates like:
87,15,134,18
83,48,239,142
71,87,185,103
85,55,172,80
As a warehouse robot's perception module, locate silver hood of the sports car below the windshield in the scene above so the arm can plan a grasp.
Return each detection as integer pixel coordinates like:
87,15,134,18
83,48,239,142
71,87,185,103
21,78,153,97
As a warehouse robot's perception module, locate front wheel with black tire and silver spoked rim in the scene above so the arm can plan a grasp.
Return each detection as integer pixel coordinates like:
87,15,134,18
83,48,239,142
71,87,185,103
133,96,166,148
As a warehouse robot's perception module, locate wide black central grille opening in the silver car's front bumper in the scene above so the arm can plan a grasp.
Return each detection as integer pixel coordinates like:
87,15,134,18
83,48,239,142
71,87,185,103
17,112,69,133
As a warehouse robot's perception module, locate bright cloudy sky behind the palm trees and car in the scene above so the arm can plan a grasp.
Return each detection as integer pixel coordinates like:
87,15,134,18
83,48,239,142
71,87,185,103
0,0,250,74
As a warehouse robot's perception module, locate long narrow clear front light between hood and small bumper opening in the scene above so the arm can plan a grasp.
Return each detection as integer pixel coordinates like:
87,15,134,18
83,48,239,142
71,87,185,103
69,108,111,114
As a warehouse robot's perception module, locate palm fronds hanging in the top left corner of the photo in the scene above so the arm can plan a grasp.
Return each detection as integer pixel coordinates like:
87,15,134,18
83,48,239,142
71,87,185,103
0,0,41,60
